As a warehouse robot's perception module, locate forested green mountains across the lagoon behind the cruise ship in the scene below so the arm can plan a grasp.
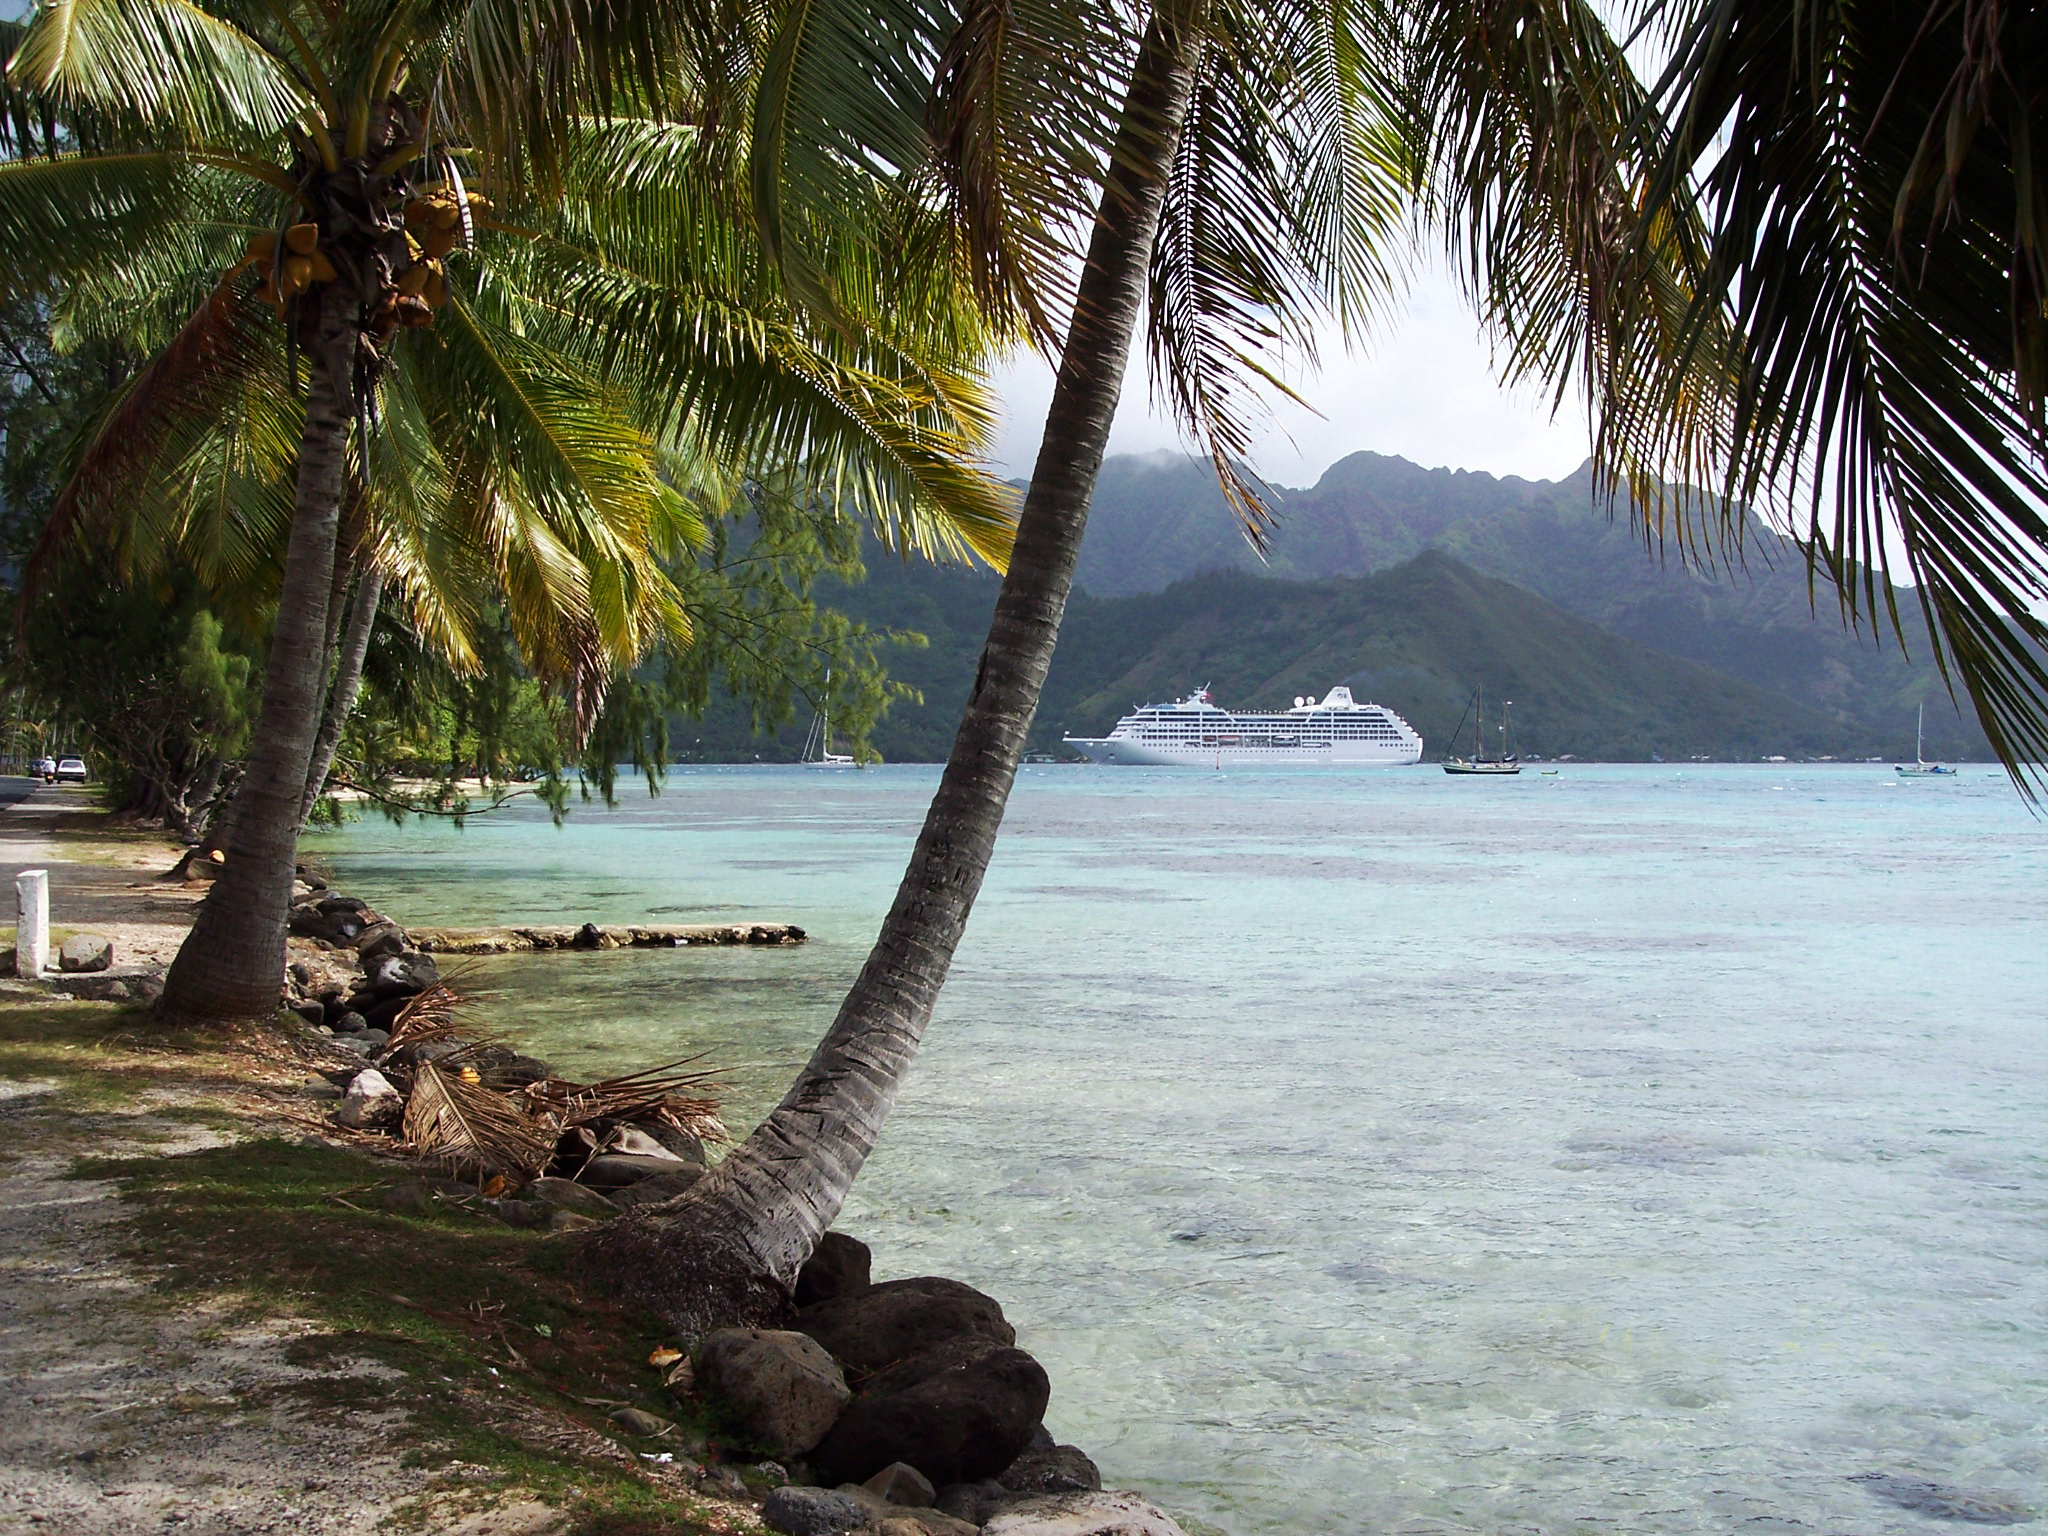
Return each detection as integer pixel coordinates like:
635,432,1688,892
676,453,1989,762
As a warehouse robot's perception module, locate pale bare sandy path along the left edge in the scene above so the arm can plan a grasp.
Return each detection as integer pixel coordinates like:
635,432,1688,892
0,786,561,1536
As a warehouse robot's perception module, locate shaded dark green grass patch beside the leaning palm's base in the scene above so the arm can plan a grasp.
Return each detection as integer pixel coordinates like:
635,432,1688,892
78,1139,765,1536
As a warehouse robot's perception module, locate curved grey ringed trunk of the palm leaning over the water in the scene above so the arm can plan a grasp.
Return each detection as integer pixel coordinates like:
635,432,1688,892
586,2,1200,1333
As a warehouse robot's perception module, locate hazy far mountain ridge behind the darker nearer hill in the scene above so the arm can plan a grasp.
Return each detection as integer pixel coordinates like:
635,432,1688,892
1079,453,1989,758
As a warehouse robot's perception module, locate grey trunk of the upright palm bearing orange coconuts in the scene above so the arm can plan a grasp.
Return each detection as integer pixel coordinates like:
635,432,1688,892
158,294,360,1020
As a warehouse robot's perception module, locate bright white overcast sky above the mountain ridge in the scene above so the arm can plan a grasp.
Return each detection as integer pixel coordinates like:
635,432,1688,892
997,259,1587,485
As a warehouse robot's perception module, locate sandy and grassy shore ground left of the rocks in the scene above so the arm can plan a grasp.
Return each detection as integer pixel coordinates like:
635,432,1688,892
0,786,762,1536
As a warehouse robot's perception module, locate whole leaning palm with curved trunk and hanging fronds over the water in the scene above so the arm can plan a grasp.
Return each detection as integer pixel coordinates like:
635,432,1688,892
590,0,1716,1329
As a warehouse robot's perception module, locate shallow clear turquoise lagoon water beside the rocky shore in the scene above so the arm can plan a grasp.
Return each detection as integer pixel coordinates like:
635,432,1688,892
307,766,2048,1536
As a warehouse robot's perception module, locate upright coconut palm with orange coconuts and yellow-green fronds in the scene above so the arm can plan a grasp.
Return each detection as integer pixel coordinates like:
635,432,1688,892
0,0,1008,1018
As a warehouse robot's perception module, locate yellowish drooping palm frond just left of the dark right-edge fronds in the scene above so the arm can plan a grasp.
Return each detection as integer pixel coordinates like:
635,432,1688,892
1405,0,1749,563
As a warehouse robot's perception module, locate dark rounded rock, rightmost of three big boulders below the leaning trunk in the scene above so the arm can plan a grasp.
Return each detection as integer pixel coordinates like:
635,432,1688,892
811,1335,1053,1483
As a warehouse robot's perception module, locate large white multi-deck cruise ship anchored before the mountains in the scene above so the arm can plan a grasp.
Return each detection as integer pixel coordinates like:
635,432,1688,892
1061,688,1421,768
